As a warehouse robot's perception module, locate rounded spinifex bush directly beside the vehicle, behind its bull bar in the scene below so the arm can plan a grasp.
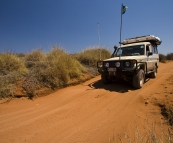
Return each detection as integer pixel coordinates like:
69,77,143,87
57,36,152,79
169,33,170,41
73,47,111,66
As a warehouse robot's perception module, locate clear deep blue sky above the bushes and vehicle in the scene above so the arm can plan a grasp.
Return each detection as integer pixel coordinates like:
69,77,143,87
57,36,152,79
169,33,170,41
0,0,173,54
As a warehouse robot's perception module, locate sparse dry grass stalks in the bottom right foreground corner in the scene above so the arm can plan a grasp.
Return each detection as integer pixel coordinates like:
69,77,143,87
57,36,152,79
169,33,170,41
109,119,173,143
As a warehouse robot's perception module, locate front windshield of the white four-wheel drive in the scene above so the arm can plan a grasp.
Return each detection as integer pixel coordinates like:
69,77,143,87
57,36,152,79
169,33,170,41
114,45,144,57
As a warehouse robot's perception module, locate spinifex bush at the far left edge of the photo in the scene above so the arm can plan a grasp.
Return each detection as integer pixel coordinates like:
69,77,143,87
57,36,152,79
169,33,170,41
0,53,27,98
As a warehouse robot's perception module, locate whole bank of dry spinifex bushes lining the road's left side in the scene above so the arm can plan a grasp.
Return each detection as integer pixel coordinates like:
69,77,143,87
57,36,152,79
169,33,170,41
0,47,111,99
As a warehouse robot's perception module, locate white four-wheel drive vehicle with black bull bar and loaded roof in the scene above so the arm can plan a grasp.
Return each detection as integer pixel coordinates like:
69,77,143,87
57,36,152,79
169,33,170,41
97,35,162,88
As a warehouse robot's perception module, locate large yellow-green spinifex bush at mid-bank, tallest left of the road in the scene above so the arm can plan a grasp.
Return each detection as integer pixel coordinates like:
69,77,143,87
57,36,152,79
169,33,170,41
42,47,85,88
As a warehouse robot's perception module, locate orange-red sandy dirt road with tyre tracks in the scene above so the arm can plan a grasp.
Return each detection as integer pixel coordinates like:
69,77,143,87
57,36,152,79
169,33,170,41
0,62,173,143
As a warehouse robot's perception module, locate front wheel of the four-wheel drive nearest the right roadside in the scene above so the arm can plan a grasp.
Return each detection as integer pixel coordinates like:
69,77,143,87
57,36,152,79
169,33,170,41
133,69,145,89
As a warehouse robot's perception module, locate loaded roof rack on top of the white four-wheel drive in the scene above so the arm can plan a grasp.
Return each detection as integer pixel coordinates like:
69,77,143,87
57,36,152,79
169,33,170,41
120,35,162,45
